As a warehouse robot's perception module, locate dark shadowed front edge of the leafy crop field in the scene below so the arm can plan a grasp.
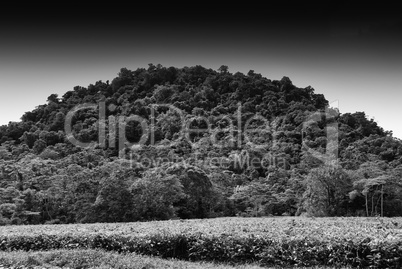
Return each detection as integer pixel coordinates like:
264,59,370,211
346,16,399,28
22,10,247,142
0,228,402,268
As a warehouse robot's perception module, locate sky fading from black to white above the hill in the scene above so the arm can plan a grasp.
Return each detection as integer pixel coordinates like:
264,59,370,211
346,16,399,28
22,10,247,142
0,4,402,138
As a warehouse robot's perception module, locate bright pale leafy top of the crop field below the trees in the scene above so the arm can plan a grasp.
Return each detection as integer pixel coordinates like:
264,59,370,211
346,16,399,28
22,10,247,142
0,217,402,238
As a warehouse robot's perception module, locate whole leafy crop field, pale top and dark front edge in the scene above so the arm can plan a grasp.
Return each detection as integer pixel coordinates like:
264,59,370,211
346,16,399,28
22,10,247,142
0,217,402,268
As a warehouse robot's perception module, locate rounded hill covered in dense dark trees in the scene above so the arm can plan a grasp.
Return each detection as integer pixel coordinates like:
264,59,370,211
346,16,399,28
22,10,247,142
0,64,402,224
